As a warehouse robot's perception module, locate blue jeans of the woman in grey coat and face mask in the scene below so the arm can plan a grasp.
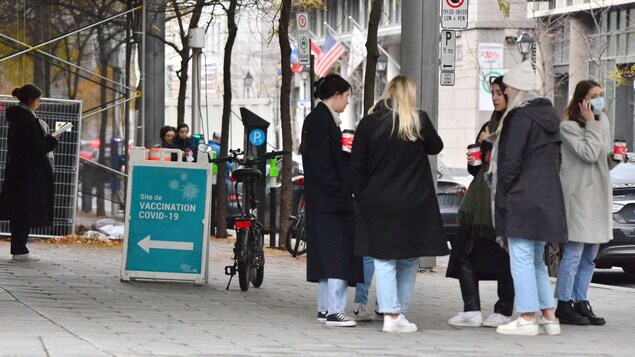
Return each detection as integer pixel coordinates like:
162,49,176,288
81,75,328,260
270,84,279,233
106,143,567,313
556,242,600,301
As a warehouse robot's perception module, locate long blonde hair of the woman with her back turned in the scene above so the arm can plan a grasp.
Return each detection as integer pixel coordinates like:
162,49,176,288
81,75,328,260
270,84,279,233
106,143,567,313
369,75,422,141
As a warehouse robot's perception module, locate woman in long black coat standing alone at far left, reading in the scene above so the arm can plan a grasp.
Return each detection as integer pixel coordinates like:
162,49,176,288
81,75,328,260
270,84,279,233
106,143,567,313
0,84,58,260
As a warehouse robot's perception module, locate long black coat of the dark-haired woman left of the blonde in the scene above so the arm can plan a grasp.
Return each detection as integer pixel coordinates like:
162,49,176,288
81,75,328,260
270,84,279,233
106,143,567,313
300,103,364,285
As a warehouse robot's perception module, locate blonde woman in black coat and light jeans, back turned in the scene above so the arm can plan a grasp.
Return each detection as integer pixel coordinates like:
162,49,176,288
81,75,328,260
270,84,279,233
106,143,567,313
351,76,448,332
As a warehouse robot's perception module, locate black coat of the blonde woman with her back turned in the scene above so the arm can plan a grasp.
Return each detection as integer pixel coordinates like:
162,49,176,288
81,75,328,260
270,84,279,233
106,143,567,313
351,103,448,259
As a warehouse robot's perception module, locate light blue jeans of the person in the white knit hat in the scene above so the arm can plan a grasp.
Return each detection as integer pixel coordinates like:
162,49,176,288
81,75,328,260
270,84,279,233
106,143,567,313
508,238,555,313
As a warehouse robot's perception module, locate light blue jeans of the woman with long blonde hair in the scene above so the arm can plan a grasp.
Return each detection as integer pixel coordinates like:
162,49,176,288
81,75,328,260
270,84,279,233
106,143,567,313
375,258,419,314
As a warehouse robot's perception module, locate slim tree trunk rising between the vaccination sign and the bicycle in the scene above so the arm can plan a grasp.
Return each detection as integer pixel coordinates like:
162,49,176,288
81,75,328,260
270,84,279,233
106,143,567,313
216,0,238,238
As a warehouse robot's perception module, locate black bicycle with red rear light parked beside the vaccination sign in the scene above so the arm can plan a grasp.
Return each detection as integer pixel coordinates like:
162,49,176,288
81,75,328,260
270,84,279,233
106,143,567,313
211,149,288,291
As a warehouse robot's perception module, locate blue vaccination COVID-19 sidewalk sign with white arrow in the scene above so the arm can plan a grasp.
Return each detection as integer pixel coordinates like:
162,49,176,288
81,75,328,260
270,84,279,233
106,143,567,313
121,148,211,283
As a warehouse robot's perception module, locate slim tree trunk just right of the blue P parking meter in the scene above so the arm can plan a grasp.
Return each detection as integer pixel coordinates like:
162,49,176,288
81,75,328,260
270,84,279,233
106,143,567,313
278,0,293,249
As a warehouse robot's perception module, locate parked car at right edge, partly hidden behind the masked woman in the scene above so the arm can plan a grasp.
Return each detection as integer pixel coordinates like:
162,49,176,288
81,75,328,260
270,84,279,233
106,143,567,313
545,161,635,278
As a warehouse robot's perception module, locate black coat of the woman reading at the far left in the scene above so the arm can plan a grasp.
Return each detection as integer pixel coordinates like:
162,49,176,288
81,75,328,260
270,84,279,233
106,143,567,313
0,105,57,227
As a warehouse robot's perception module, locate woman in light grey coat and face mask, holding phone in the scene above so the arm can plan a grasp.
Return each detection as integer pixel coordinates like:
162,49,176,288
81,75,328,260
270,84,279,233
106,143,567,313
556,80,614,325
